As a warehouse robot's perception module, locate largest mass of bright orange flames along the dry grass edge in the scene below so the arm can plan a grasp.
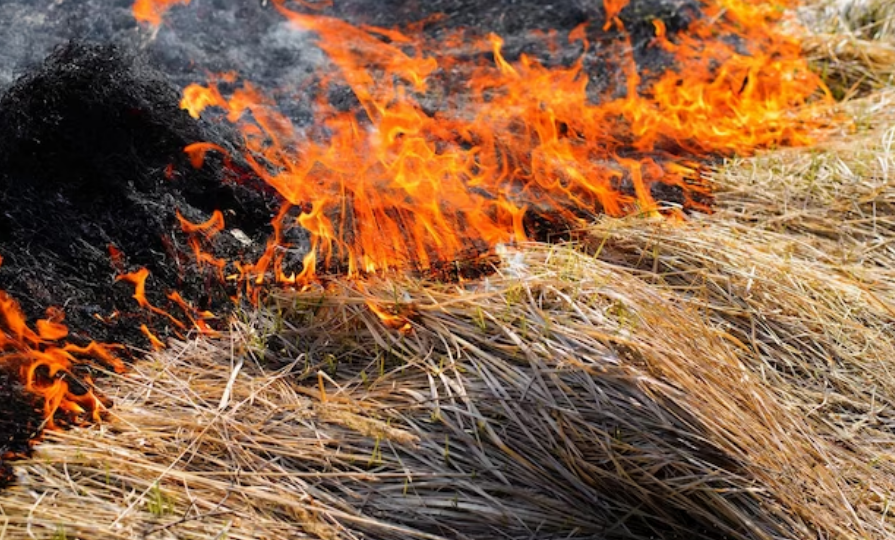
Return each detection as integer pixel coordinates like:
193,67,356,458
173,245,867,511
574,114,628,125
182,0,822,283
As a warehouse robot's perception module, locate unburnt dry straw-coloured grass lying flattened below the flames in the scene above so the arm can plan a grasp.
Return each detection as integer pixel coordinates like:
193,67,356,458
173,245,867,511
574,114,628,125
0,10,895,540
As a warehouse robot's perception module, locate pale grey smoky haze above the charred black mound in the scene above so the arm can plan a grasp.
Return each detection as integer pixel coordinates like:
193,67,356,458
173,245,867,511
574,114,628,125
0,0,324,89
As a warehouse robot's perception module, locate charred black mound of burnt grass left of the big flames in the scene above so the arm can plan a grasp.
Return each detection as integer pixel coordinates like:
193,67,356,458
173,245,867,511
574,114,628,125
0,43,278,344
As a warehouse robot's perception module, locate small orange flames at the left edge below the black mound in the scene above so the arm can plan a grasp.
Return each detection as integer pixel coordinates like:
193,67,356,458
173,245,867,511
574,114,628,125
0,260,124,429
